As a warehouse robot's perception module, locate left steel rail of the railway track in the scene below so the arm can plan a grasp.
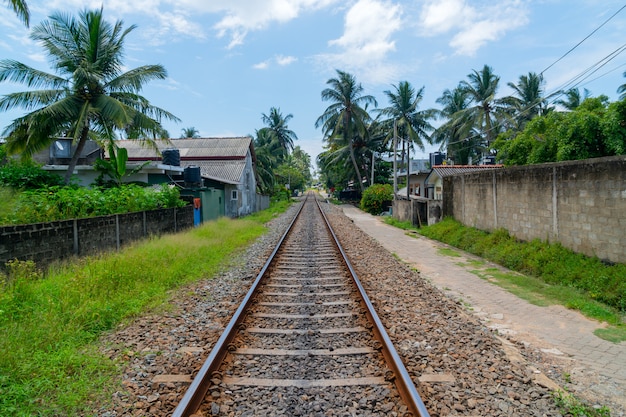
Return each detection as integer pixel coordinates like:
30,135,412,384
172,196,309,417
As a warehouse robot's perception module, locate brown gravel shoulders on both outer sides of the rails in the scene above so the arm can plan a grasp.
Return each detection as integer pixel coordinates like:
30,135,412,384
97,199,584,417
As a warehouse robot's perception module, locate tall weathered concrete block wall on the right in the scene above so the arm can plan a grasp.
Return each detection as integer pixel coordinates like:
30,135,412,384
443,156,626,263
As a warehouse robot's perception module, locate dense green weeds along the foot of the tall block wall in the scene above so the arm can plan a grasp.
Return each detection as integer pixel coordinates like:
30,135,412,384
420,218,626,312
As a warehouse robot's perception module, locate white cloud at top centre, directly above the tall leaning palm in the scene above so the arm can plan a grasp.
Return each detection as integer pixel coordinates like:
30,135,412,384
317,0,402,83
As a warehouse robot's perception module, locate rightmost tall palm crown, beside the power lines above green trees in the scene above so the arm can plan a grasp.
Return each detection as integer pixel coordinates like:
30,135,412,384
503,72,556,130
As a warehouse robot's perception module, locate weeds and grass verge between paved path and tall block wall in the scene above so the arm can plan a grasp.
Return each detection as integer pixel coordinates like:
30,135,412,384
386,214,626,342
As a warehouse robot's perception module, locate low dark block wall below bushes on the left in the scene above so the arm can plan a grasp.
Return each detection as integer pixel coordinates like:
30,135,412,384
0,205,193,269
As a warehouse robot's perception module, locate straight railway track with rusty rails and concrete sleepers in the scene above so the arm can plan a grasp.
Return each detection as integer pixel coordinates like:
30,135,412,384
173,197,428,417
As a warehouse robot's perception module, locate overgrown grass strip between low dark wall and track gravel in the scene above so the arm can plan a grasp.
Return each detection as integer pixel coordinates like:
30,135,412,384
0,202,289,416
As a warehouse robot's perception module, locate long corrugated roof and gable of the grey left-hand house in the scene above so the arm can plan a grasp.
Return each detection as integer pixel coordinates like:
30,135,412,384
117,137,255,184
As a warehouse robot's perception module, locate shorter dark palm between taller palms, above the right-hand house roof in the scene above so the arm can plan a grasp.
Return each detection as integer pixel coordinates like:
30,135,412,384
431,85,477,165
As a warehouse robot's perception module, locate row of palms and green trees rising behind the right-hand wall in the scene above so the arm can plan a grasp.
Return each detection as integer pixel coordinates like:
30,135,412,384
315,65,626,191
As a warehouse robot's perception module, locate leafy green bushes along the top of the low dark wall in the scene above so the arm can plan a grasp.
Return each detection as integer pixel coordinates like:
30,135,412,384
0,184,185,224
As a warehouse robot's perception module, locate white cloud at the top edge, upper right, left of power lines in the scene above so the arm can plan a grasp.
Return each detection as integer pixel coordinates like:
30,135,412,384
420,0,528,56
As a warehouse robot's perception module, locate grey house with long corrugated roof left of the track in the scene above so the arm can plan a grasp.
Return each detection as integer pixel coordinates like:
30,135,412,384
116,136,269,221
